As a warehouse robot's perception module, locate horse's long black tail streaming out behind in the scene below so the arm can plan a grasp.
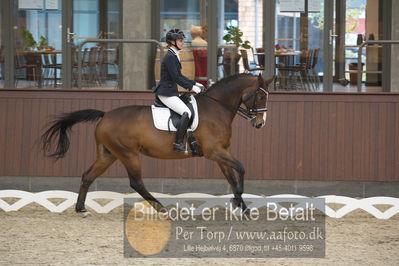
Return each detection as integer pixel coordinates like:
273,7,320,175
41,109,105,159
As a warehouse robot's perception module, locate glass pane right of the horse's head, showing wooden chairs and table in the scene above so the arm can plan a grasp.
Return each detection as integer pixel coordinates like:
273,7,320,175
274,0,336,91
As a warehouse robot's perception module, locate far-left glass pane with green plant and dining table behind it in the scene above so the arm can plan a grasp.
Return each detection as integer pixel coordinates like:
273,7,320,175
11,0,62,88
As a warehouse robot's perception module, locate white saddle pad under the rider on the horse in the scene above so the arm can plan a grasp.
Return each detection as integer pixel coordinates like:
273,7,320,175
151,95,199,131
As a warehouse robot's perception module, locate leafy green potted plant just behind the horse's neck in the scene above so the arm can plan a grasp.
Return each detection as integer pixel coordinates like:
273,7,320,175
223,26,251,74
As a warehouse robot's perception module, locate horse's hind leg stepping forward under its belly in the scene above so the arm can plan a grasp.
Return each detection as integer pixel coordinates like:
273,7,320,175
121,154,163,212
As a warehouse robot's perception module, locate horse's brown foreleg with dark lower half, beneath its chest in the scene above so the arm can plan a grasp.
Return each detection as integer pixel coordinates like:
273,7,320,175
210,150,248,213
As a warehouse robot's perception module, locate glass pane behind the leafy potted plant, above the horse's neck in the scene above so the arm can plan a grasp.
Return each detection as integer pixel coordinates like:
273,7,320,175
217,0,264,79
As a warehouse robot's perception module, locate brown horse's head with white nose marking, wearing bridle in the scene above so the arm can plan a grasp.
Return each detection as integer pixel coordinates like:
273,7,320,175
241,74,274,128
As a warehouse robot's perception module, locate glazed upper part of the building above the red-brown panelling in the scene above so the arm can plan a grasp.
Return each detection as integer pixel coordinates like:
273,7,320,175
0,0,399,92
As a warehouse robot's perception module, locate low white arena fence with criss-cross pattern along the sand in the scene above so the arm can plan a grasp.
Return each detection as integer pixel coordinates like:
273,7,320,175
0,190,399,219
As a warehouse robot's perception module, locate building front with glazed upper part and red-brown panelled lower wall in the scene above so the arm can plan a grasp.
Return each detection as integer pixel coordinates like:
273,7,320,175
0,0,399,188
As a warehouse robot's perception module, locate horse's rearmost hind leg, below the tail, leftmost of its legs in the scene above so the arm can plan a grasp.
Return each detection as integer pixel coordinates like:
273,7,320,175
75,145,116,212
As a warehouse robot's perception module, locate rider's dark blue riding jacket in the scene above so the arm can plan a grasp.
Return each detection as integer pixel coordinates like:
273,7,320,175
154,48,195,96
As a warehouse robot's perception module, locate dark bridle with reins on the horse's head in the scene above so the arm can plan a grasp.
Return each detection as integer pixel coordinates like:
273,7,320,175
201,85,269,122
